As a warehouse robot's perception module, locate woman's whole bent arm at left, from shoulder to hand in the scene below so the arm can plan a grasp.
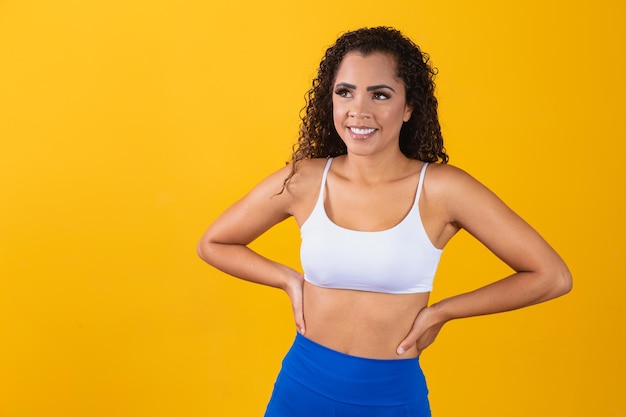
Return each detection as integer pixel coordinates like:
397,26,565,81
198,159,316,334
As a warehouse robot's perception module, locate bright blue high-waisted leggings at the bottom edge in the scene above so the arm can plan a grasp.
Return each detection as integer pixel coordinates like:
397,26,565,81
265,334,431,417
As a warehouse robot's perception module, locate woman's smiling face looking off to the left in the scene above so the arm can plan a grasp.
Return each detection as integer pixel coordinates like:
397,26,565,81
333,52,412,155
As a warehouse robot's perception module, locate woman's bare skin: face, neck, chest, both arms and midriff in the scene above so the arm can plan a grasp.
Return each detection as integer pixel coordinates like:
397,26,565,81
198,53,572,359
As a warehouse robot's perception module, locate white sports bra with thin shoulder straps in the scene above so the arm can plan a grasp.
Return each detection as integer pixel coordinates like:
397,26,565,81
300,158,442,294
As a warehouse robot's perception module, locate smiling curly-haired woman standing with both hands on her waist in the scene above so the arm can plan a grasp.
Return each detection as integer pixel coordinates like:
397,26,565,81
198,27,571,417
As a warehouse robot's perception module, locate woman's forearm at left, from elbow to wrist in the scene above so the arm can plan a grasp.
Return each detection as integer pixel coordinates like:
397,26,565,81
198,242,299,289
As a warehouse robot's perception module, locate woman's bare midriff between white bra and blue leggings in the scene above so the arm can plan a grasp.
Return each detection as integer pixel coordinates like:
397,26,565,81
304,281,430,359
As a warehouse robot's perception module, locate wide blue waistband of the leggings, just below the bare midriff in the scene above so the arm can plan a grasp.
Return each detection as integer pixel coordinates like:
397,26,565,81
281,333,428,406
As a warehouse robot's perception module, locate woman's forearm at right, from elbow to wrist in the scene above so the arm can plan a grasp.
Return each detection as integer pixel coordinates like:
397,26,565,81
432,268,571,322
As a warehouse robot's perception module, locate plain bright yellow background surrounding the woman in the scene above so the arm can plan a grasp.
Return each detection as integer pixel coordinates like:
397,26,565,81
0,0,626,417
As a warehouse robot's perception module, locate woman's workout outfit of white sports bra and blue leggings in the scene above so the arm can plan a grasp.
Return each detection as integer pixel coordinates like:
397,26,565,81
265,158,442,417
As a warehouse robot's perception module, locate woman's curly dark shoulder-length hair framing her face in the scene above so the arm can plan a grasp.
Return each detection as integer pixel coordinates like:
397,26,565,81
285,26,448,183
